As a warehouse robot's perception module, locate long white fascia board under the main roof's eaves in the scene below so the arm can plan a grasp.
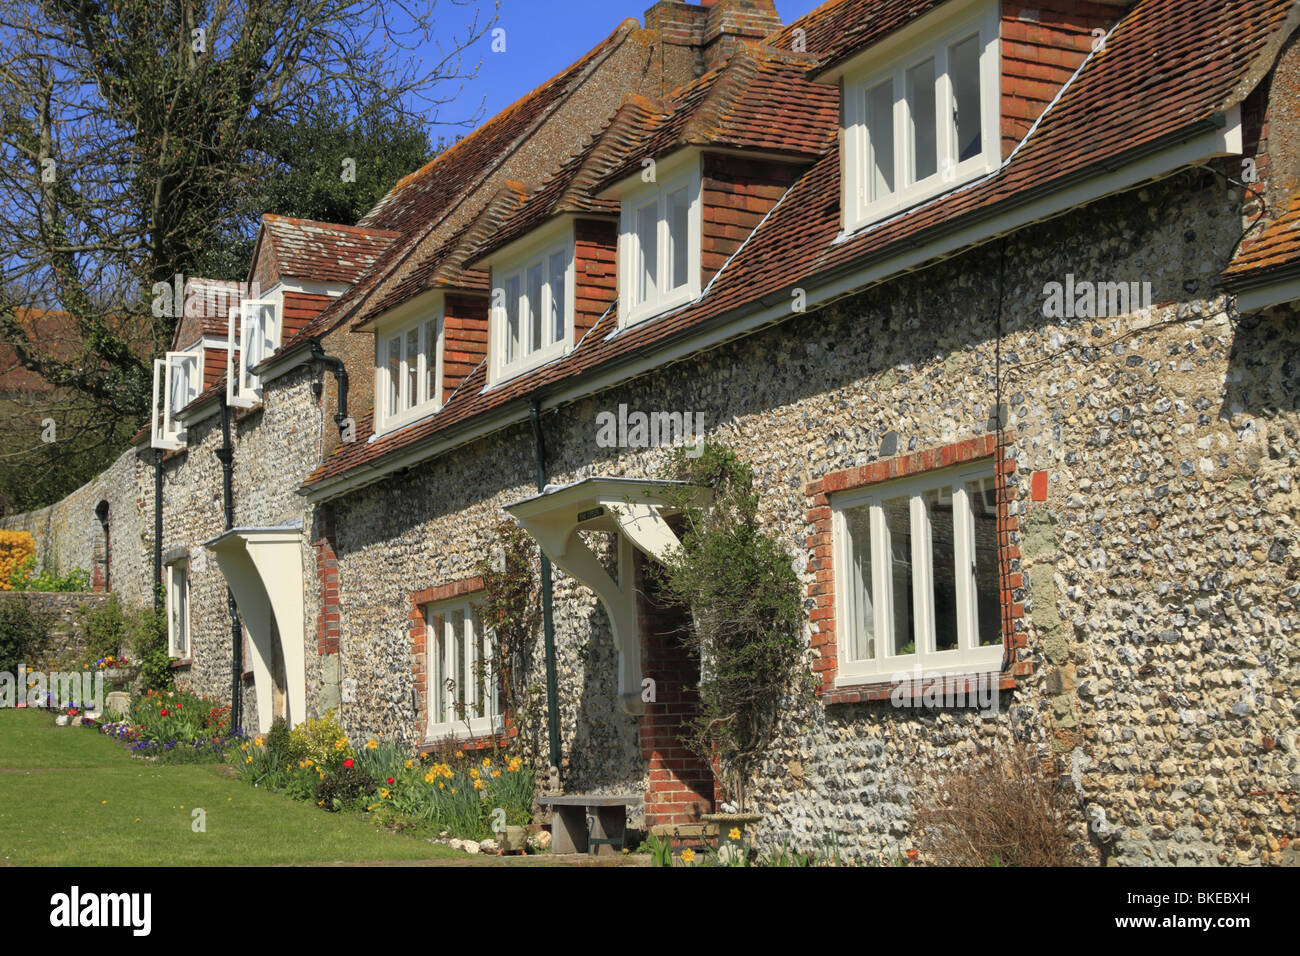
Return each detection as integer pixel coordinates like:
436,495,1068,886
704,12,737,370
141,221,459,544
299,121,1242,502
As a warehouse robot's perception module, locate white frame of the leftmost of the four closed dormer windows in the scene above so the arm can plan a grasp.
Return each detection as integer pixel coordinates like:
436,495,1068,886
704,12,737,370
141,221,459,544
374,295,446,434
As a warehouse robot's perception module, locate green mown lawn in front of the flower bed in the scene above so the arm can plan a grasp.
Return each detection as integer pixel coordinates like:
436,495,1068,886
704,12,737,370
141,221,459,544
0,710,468,866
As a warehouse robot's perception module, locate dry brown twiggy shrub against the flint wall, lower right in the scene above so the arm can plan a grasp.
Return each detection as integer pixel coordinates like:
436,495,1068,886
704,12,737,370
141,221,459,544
913,741,1086,866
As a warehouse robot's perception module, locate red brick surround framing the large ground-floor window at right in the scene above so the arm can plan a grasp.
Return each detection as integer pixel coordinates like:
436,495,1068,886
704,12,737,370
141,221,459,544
806,433,1028,705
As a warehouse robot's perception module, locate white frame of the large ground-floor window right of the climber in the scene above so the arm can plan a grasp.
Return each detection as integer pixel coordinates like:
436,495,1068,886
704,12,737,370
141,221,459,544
831,459,1005,685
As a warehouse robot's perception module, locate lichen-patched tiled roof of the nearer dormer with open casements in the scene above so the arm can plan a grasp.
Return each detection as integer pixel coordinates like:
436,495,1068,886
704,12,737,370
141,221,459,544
261,213,398,285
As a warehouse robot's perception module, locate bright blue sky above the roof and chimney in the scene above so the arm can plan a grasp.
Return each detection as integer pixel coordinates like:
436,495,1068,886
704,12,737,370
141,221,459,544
423,0,823,138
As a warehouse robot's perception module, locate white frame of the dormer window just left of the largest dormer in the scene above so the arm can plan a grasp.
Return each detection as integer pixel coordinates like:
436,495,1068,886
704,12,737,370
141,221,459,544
619,152,703,326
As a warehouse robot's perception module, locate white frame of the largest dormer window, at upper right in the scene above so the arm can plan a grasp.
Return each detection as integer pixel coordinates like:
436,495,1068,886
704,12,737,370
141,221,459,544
844,0,1002,232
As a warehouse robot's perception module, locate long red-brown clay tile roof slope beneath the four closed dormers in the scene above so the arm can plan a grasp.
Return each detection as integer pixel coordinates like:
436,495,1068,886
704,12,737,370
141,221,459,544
299,0,1300,488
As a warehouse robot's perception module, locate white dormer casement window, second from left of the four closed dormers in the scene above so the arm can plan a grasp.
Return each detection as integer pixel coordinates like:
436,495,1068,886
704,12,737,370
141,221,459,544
489,230,575,384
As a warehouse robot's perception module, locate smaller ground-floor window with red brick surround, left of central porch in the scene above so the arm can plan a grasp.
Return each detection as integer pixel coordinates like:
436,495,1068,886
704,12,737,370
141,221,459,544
408,576,515,749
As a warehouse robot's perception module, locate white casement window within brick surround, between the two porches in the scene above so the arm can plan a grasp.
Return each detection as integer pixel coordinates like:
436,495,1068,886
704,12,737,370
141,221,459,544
424,600,502,739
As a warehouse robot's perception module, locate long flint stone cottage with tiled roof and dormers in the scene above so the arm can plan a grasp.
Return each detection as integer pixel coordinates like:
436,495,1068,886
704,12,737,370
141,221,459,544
4,0,1300,865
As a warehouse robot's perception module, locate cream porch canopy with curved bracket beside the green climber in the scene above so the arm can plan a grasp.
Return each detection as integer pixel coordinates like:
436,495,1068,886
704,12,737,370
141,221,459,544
506,477,709,715
